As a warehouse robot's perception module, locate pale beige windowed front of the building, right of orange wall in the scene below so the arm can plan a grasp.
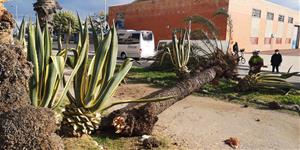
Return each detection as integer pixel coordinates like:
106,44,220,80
227,0,300,52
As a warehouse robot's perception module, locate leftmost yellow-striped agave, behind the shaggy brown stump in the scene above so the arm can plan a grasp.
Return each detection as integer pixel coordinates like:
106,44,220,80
25,17,86,109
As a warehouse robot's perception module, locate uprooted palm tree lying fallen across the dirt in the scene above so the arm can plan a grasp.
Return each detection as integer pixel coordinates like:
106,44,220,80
102,8,237,136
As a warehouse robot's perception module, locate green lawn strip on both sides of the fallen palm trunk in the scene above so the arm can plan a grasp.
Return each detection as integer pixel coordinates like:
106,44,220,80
127,67,300,105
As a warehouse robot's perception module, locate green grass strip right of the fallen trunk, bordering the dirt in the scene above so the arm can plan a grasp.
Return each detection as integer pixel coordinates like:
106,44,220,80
199,79,300,105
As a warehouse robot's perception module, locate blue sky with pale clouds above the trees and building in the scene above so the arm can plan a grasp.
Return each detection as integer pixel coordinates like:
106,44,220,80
5,0,300,23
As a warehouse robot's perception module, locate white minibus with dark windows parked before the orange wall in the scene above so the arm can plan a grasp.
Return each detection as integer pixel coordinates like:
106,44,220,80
118,30,156,59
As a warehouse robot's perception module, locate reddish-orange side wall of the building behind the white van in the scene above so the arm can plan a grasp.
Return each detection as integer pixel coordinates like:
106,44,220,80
109,0,228,43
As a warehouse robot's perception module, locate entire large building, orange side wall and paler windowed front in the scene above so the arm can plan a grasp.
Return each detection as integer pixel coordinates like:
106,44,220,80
109,0,300,51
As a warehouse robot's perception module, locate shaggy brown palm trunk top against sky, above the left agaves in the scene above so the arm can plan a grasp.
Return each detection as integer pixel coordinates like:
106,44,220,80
33,0,62,29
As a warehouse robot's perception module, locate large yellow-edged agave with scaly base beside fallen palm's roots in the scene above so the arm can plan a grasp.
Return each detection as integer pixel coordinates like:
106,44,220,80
61,19,166,136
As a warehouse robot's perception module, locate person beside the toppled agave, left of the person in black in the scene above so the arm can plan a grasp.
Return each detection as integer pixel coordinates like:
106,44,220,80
248,51,264,75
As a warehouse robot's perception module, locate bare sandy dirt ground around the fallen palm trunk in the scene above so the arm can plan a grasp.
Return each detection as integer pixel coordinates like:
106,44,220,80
115,84,300,150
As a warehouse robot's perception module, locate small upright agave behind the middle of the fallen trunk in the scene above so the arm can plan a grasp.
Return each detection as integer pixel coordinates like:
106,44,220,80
161,30,191,77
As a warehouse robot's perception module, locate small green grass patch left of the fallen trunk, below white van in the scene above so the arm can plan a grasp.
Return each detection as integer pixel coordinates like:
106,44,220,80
127,67,178,86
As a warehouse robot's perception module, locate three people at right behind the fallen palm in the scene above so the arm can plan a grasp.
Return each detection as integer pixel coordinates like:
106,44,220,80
233,42,282,75
